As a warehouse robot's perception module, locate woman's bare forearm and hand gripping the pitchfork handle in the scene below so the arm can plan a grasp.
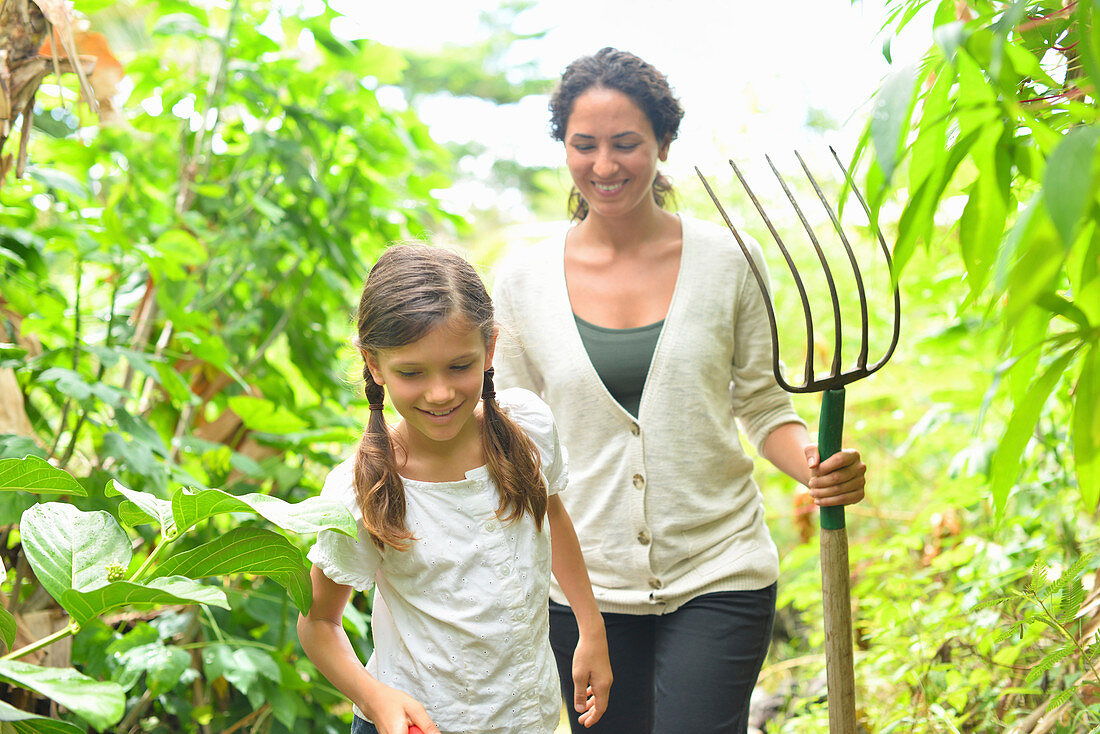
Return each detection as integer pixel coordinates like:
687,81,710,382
761,423,867,507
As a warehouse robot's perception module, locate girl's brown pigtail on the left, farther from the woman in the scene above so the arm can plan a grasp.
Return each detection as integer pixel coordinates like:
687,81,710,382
355,365,414,550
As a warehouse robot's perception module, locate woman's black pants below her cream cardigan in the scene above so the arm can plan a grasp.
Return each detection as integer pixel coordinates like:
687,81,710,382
550,584,777,734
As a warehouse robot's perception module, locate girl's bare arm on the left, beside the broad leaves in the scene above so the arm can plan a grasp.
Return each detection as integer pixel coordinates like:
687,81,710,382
298,566,439,734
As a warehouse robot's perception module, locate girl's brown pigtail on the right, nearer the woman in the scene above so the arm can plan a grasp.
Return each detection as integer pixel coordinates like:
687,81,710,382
482,368,547,530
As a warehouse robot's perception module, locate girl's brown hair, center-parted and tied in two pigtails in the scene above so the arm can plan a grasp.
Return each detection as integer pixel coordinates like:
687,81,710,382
355,244,547,550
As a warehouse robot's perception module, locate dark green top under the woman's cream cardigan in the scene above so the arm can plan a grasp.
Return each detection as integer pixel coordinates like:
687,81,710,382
573,314,664,418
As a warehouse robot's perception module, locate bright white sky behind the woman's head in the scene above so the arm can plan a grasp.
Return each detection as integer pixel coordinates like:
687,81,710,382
337,0,923,215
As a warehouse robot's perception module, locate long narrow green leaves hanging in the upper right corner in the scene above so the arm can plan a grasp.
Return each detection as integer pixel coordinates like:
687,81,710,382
865,0,1100,512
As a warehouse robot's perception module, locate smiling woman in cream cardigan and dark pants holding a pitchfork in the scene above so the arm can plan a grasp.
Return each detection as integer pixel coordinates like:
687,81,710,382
495,48,866,734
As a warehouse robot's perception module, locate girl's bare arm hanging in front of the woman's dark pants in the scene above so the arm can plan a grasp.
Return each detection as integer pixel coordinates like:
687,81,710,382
547,494,612,726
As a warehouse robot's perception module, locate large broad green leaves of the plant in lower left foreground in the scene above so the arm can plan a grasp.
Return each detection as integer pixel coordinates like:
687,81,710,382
0,458,356,731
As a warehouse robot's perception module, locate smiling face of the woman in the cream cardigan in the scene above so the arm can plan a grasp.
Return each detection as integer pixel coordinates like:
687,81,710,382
565,87,669,218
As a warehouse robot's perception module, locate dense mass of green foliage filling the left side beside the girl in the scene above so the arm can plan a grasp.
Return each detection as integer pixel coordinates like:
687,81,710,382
0,0,464,734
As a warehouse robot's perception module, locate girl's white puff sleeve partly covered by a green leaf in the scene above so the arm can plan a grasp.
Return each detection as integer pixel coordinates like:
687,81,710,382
307,457,382,591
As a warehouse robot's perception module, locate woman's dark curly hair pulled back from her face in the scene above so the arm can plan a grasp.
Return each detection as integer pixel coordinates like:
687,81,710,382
550,47,684,221
